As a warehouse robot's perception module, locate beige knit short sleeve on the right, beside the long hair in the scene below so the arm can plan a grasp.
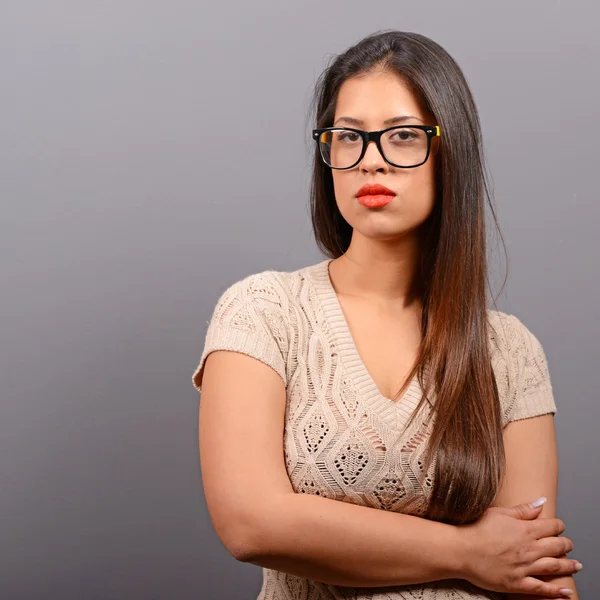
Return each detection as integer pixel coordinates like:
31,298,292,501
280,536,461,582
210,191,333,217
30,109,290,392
504,315,556,424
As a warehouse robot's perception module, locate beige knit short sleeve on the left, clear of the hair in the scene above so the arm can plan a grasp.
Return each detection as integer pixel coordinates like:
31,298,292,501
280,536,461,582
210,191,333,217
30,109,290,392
192,271,288,391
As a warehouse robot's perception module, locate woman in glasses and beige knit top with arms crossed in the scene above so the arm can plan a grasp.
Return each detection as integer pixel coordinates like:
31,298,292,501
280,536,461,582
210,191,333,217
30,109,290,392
193,31,580,600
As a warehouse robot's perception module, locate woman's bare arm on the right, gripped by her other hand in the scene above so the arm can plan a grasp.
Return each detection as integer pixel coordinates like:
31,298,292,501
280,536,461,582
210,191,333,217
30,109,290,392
493,414,579,600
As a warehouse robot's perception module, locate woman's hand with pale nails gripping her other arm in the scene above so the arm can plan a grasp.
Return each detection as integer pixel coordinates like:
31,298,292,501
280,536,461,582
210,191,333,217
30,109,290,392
460,504,577,598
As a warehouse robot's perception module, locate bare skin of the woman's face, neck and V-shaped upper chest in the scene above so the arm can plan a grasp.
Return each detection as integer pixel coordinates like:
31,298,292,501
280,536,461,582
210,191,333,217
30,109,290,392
330,72,439,399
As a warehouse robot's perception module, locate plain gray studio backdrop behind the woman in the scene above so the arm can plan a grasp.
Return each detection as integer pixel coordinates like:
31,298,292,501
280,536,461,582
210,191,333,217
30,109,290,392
0,0,600,600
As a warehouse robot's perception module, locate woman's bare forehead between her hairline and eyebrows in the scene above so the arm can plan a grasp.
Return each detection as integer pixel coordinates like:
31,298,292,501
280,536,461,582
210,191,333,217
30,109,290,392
334,72,428,123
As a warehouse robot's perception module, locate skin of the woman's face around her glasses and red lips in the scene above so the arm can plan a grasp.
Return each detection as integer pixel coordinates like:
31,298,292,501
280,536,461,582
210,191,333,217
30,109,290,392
331,72,439,240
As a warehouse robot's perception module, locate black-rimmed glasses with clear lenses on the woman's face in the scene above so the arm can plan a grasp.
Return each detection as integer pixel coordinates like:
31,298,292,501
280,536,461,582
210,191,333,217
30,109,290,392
313,125,440,169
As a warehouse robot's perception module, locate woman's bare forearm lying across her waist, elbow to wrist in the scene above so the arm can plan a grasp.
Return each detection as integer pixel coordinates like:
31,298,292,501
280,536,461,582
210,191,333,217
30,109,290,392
241,494,464,587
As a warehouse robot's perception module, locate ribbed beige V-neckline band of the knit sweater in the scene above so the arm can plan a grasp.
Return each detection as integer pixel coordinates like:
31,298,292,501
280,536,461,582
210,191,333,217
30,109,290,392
310,259,422,427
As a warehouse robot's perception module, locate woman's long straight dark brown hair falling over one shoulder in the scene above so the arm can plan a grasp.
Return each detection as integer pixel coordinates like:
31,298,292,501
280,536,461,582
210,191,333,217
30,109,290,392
310,30,506,524
